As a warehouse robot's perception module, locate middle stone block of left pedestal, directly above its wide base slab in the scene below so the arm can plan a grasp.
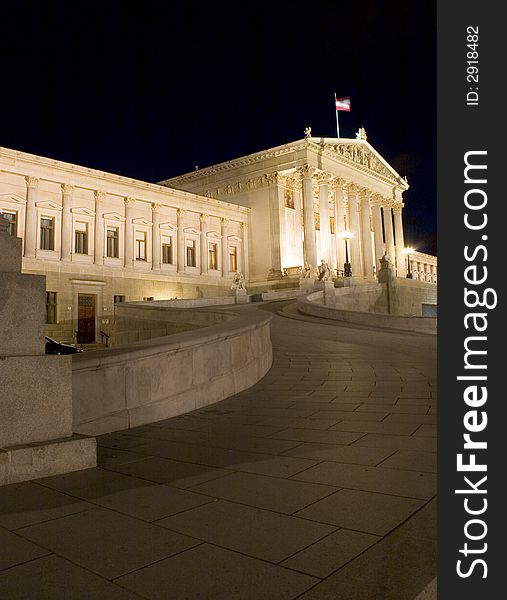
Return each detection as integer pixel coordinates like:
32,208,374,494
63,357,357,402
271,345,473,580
0,356,72,447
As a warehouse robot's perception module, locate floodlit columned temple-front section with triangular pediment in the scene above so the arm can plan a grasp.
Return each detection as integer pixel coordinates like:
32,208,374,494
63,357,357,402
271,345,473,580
162,134,436,282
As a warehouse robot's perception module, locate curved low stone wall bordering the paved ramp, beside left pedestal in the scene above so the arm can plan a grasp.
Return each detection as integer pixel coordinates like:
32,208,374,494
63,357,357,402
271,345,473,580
72,307,272,435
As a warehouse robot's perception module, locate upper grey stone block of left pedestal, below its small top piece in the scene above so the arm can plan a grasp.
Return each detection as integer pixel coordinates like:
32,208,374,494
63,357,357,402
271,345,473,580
0,272,46,356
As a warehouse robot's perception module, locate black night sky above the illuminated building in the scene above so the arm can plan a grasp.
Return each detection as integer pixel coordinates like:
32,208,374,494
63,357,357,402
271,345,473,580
0,0,436,253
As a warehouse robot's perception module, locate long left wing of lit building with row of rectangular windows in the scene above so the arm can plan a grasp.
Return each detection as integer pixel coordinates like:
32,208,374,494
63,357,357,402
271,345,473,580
0,148,250,343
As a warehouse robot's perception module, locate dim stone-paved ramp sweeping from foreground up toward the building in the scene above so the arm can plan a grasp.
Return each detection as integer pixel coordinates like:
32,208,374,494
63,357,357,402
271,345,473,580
0,302,436,600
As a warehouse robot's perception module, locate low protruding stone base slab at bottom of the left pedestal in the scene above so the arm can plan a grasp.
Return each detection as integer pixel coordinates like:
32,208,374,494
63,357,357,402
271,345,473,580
0,435,97,486
